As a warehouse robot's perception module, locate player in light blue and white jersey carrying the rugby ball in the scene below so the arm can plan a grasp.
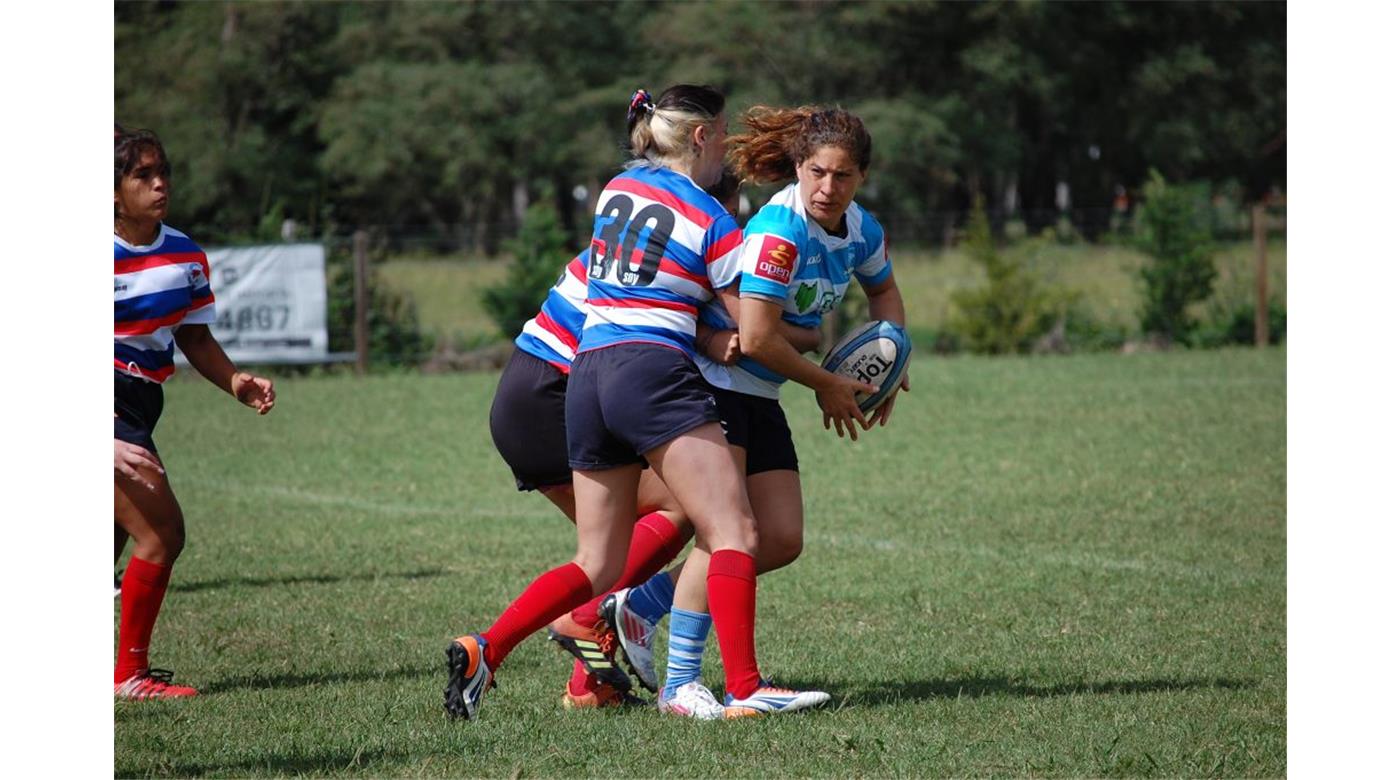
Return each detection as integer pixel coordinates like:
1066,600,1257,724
603,106,907,714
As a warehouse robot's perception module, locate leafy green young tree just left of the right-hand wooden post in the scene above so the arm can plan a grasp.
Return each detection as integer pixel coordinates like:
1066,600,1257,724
1137,171,1217,343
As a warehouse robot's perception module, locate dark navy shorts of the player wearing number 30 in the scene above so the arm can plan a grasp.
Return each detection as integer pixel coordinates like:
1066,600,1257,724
566,343,720,471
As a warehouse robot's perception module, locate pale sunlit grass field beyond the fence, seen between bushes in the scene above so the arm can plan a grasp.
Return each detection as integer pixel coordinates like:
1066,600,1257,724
378,241,1288,343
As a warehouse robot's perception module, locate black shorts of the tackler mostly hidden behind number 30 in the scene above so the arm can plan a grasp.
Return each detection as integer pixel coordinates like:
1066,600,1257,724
491,347,573,490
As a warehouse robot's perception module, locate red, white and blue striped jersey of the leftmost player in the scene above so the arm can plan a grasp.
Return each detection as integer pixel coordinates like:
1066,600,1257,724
112,224,214,382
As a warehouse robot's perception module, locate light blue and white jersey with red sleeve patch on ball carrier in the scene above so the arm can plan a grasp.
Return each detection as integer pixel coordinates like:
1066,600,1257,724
696,182,893,398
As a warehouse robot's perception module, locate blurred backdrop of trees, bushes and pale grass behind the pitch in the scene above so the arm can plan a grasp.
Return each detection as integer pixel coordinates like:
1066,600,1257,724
115,1,1287,368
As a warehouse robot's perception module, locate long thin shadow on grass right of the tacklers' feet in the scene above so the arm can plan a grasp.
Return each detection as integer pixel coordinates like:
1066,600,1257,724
823,676,1254,707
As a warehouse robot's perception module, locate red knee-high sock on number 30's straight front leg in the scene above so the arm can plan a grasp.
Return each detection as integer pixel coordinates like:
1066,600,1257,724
706,550,759,699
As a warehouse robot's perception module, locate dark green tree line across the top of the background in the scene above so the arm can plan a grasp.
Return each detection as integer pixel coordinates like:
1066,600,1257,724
115,0,1287,251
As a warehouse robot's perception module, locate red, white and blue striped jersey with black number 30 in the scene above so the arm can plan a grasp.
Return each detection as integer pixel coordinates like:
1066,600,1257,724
578,165,743,357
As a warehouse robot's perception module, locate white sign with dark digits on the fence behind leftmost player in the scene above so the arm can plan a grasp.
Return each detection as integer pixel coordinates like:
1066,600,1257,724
196,244,328,363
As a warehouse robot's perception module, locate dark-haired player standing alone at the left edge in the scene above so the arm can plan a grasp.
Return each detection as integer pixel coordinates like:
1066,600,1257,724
112,127,276,699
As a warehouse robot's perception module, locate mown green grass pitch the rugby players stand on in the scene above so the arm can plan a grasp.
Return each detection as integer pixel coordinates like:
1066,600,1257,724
115,349,1287,777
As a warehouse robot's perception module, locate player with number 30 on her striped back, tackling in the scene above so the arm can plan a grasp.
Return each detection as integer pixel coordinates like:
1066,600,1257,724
445,85,830,717
